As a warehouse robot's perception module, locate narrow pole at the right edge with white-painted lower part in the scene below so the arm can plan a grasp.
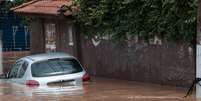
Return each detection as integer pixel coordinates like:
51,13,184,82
196,0,201,99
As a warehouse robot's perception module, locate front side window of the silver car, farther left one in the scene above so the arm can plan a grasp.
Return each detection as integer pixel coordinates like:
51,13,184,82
9,61,23,78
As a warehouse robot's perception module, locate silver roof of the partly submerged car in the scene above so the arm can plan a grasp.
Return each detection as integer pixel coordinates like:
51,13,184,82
24,52,75,61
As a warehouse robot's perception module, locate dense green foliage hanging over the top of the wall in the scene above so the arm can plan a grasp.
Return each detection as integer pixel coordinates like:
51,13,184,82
74,0,197,41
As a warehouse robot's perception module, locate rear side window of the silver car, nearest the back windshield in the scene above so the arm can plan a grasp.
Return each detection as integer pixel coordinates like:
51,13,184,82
17,61,29,78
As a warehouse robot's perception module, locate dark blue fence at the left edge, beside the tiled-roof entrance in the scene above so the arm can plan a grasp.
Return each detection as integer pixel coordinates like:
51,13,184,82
0,3,30,51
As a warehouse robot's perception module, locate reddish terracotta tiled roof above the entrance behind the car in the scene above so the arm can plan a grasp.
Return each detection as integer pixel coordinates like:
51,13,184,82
11,0,72,16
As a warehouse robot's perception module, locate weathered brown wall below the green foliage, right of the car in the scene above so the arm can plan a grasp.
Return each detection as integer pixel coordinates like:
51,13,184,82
82,39,195,87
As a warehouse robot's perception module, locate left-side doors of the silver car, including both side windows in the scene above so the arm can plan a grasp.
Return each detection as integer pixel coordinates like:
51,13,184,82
8,60,28,83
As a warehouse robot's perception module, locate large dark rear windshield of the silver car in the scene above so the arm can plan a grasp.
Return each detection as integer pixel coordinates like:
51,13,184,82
31,59,83,77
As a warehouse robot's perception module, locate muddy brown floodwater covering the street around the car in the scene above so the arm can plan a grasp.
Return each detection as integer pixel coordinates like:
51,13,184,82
0,78,197,101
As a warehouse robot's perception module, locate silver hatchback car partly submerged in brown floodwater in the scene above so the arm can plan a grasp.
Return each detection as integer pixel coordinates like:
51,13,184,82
2,53,90,85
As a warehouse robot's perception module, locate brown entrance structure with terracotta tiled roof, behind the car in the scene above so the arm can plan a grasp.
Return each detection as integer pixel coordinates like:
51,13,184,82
12,0,79,57
